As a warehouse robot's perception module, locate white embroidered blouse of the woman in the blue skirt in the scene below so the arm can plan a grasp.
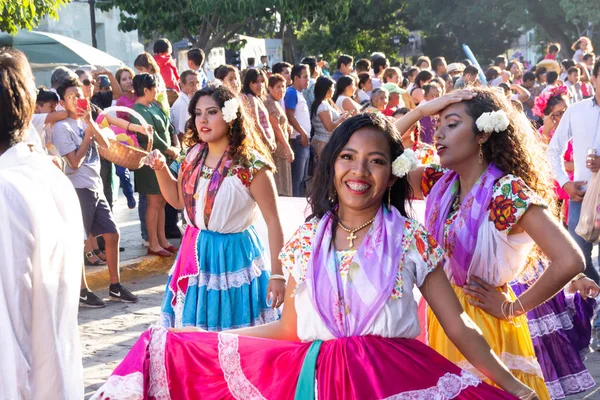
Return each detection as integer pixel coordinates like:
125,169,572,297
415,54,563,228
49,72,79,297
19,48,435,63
182,146,269,233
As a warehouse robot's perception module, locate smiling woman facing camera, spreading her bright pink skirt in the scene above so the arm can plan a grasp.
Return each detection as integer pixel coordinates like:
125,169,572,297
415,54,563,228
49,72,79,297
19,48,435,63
94,114,537,400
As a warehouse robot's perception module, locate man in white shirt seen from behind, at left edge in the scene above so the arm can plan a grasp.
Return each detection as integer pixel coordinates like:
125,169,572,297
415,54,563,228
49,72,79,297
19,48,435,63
0,50,84,400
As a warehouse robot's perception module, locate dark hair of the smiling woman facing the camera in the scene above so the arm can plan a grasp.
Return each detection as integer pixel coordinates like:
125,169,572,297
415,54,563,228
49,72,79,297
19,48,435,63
307,113,412,221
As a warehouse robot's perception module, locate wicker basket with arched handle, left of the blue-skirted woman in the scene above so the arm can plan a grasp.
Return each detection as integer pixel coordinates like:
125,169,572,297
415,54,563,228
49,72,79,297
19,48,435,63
98,106,153,170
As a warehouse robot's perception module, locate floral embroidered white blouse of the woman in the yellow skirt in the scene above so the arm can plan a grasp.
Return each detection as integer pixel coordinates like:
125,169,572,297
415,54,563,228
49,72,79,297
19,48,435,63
421,164,546,286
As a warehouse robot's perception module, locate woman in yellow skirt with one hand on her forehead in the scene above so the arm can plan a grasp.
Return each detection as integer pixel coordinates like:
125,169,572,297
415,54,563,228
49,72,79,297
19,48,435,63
396,88,583,399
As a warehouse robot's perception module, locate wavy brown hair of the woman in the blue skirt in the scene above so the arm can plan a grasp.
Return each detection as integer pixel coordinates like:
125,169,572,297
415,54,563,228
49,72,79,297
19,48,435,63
183,84,274,170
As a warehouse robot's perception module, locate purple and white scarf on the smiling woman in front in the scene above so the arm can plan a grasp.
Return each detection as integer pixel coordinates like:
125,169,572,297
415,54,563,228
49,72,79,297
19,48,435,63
306,207,404,338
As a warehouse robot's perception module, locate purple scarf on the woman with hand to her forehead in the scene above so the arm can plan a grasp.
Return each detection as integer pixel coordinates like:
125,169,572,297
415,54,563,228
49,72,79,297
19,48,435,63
425,164,504,286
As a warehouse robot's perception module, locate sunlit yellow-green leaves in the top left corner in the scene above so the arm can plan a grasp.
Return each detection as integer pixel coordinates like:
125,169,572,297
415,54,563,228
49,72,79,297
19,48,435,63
0,0,69,35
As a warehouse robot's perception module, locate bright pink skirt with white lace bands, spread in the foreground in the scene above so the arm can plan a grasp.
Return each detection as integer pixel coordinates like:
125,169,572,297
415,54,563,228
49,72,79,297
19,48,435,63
92,328,515,400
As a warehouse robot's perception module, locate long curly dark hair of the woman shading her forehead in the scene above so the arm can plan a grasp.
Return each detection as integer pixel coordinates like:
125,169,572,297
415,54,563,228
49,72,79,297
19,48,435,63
462,87,555,211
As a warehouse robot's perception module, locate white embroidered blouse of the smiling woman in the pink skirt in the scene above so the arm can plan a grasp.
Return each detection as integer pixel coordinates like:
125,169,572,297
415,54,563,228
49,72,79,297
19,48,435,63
279,218,444,341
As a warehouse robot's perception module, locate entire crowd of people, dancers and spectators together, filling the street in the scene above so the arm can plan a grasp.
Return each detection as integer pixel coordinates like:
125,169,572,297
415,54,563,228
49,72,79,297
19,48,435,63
0,37,600,399
